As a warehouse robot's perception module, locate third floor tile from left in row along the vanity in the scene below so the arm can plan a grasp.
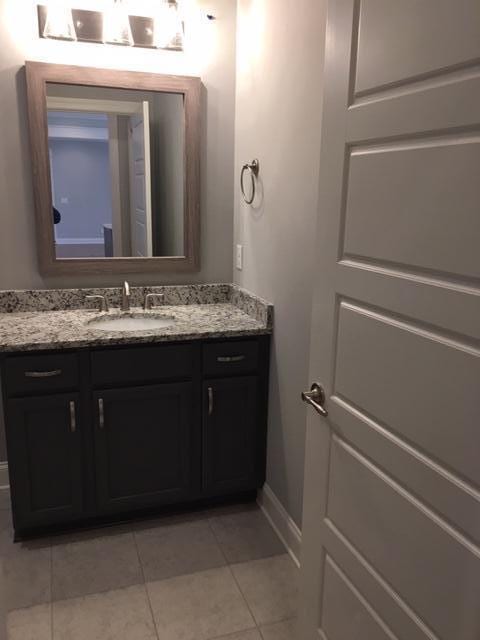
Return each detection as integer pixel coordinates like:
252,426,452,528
135,520,225,582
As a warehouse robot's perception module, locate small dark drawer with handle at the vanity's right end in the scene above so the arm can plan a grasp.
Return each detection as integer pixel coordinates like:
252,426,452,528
203,340,258,376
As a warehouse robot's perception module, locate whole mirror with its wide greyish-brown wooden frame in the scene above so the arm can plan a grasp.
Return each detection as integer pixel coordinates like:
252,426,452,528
26,62,201,275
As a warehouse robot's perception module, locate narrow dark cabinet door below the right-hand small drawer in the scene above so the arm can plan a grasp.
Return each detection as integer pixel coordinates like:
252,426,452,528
204,376,263,494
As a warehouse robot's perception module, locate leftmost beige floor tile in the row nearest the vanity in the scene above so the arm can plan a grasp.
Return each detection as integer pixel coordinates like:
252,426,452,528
3,540,52,610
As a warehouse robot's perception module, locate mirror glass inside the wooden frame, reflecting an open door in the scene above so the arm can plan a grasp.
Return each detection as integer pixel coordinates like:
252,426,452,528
47,83,185,259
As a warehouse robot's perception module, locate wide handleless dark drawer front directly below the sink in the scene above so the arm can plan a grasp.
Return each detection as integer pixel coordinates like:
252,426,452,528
91,344,196,387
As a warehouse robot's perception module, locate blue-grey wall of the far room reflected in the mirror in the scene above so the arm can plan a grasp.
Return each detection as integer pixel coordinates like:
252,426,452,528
49,140,112,239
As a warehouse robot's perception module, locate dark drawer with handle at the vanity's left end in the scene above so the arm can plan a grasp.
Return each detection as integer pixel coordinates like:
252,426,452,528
4,353,79,396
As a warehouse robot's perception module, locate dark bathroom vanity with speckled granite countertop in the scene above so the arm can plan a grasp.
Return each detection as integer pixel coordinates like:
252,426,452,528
0,285,272,536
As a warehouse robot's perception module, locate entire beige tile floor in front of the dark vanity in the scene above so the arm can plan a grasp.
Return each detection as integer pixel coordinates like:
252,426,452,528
0,496,297,640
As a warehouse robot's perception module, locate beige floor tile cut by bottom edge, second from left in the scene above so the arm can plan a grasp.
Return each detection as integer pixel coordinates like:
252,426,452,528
53,585,157,640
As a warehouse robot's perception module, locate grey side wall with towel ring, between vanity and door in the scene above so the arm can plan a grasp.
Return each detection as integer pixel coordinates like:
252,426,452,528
234,0,325,526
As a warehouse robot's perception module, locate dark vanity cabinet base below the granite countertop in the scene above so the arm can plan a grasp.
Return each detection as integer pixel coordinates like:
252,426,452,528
2,336,269,535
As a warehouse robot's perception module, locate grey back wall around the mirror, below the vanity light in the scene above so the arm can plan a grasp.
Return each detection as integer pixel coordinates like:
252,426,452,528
0,0,236,289
